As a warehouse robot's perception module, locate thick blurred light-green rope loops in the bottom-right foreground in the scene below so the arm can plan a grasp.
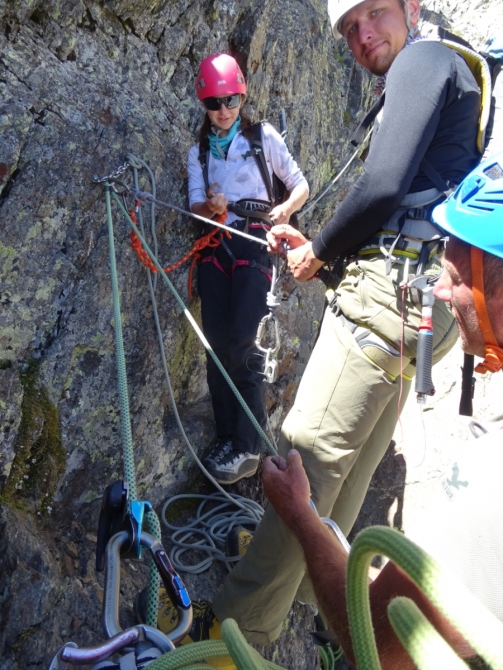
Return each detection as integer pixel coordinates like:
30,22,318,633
346,526,503,670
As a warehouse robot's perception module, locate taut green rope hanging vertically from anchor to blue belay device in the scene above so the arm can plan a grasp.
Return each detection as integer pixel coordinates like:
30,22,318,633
105,184,161,626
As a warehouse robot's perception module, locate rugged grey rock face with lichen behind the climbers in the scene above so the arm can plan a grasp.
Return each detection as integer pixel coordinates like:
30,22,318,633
0,0,501,670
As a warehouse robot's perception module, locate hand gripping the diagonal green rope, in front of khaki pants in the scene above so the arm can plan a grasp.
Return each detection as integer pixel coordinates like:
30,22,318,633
262,449,311,527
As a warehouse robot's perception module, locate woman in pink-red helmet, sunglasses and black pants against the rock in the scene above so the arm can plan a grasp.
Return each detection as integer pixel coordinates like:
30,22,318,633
188,54,309,484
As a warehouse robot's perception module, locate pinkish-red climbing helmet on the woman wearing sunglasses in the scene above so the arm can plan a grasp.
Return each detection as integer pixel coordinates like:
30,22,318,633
196,54,246,100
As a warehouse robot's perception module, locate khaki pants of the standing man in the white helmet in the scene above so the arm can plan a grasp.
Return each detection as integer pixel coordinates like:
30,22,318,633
213,259,457,644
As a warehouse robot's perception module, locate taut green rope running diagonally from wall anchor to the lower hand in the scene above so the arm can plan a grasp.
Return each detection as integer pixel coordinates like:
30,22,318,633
106,190,277,456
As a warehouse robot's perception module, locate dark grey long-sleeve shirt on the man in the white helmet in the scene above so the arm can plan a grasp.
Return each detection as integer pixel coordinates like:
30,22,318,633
313,40,480,261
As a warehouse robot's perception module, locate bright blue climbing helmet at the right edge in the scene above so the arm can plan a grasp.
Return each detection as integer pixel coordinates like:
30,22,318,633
433,152,503,258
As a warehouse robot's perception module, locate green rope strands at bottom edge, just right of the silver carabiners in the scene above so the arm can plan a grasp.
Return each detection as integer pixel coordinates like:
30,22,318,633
148,619,283,670
